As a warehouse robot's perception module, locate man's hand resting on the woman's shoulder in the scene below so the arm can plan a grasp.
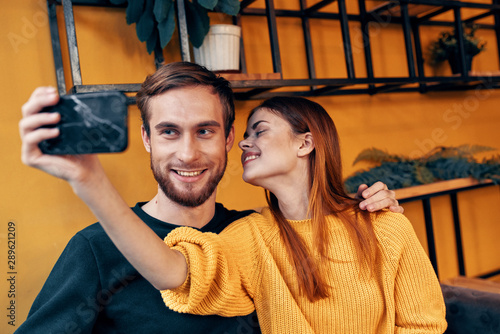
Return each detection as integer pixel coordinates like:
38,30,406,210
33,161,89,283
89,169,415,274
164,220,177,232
356,181,404,213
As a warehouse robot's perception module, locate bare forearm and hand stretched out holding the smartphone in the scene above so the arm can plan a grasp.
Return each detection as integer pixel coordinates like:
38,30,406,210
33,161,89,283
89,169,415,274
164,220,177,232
19,87,187,290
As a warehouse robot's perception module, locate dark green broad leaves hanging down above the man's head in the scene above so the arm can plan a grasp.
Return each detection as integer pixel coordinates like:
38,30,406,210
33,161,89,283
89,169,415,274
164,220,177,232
110,0,240,54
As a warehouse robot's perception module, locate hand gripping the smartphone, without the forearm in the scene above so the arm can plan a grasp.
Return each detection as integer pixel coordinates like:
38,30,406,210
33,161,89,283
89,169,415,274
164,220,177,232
19,87,100,183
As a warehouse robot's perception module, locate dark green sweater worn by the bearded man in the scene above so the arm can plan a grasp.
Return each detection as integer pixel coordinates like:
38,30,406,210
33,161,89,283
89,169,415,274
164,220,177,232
16,203,260,334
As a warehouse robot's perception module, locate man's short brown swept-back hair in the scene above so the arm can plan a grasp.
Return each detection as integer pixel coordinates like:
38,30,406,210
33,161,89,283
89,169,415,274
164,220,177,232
136,62,234,137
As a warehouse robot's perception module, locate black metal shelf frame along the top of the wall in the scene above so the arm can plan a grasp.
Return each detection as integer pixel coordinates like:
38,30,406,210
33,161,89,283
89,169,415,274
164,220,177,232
47,0,500,102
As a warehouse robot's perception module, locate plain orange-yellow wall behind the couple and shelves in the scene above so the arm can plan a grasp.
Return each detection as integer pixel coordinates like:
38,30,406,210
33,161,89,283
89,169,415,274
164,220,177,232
0,0,500,333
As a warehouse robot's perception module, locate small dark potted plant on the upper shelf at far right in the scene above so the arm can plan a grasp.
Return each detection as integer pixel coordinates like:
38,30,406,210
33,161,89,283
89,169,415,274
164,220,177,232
429,25,486,74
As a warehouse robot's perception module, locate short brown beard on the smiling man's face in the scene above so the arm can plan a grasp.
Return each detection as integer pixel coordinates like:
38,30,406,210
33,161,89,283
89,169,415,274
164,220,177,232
150,152,227,207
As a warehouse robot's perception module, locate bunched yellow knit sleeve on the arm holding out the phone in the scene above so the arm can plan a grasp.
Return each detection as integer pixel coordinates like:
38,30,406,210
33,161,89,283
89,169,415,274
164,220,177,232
161,223,255,317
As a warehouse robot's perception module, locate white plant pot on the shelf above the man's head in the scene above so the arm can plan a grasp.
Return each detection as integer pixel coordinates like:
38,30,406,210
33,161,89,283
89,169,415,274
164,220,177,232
193,24,241,71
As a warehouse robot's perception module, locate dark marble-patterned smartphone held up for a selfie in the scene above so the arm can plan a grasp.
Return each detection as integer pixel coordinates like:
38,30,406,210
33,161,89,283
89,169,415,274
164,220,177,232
39,91,128,155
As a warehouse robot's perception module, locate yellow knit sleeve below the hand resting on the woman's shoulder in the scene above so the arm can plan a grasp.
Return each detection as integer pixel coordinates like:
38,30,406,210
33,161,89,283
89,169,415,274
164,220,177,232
378,213,447,334
